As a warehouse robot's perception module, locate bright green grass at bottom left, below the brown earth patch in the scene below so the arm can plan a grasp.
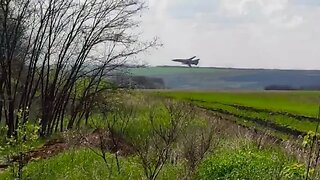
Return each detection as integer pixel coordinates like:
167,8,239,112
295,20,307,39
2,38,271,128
0,149,182,180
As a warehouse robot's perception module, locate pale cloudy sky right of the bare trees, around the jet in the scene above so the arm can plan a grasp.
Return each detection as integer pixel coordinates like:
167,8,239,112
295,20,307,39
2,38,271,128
141,0,320,70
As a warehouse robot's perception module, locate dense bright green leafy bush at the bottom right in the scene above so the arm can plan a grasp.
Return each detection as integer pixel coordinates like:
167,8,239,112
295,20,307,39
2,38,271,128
196,147,304,179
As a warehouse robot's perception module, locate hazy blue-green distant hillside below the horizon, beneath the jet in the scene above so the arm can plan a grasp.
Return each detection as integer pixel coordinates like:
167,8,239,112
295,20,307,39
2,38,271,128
129,66,320,90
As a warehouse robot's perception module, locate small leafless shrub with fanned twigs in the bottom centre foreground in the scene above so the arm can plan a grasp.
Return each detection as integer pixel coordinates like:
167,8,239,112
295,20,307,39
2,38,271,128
134,101,193,180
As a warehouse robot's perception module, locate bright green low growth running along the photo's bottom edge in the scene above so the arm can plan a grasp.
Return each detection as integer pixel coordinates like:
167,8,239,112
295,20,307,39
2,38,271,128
0,141,305,180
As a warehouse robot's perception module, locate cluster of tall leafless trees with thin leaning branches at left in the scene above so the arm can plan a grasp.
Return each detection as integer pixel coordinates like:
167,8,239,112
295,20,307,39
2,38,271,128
0,0,157,136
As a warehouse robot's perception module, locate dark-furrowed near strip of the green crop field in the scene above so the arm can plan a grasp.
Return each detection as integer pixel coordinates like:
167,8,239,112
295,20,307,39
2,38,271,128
158,92,318,139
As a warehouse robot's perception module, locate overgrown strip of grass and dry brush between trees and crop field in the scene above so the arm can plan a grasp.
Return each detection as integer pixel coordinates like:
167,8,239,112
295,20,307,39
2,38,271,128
0,93,315,179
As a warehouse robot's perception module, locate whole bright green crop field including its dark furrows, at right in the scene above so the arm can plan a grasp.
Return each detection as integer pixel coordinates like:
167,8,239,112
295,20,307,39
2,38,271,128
158,91,320,139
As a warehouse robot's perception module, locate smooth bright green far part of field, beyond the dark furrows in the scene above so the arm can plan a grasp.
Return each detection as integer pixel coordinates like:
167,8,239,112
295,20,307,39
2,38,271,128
161,91,320,117
